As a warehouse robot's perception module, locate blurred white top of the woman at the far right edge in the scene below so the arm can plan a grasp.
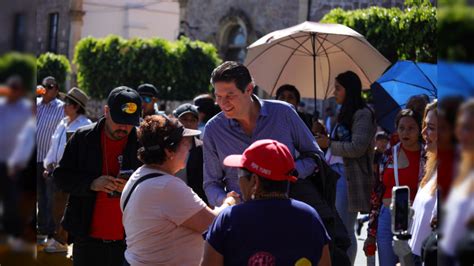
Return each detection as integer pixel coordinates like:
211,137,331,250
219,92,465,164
440,171,474,256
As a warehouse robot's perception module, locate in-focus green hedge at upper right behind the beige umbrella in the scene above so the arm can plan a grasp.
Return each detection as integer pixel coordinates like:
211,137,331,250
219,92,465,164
321,4,437,63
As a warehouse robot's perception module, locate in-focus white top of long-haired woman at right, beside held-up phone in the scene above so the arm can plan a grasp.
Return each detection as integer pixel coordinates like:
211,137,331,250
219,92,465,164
408,173,437,256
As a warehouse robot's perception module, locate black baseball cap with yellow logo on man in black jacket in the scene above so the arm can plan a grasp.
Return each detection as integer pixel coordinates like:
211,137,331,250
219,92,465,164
107,86,142,126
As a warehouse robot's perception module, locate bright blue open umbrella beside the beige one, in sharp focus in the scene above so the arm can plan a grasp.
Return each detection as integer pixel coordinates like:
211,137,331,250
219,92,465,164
370,61,437,133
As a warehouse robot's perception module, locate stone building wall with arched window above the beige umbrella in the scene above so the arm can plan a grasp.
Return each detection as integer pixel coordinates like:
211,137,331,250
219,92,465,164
179,0,404,61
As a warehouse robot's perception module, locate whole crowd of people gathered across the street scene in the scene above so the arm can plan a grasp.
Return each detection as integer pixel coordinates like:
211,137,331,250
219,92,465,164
0,61,474,266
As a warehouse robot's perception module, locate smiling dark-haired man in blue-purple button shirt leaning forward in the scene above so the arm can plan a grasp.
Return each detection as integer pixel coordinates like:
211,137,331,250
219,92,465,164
203,61,323,206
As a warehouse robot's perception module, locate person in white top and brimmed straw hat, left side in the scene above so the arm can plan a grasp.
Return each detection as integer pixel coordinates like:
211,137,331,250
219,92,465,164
43,88,92,252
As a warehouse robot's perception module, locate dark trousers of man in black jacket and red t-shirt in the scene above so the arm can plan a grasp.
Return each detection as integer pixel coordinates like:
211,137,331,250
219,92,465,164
72,238,126,266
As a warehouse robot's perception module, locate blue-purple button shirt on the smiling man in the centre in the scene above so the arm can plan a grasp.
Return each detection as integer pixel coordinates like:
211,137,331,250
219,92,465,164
203,95,323,206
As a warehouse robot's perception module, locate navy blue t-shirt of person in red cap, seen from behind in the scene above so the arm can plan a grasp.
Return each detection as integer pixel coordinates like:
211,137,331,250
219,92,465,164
205,199,330,265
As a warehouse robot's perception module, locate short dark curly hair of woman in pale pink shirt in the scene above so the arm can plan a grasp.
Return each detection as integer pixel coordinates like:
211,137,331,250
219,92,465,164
137,115,184,164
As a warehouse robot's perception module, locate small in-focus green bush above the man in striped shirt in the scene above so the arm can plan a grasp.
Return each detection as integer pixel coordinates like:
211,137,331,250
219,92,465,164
36,53,71,90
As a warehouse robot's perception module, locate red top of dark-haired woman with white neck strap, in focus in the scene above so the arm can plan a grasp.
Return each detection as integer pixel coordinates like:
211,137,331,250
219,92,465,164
383,145,421,203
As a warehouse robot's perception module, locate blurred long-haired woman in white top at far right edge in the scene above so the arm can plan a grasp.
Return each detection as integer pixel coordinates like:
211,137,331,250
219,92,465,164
440,100,474,265
